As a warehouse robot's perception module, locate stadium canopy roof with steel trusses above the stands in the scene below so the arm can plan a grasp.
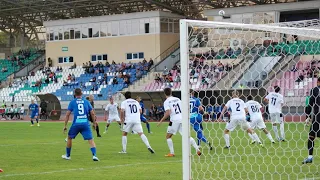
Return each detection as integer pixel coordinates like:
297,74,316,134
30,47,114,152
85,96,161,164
0,0,306,40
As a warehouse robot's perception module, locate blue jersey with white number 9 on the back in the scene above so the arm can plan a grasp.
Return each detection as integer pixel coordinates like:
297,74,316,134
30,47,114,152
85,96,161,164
68,99,93,126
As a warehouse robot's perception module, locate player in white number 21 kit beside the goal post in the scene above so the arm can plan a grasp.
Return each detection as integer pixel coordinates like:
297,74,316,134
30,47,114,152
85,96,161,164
158,88,201,157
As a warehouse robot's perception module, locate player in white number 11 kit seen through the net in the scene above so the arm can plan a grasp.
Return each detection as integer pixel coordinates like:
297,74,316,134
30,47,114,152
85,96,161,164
264,86,285,142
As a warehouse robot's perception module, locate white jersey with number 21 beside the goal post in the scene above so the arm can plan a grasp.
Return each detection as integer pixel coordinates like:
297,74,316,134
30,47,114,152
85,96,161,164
163,96,182,123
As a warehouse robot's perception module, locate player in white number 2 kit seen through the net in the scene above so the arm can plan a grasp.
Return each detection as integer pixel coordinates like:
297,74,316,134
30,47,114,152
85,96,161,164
218,91,263,149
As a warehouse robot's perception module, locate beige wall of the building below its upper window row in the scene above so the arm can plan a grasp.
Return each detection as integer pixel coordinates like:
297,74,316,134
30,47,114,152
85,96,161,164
46,34,179,66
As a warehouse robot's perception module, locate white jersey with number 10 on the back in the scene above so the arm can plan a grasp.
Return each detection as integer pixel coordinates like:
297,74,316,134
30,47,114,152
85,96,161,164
121,99,141,123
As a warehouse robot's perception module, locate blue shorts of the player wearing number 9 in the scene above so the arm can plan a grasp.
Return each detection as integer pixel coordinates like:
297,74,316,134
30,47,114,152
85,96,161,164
68,123,92,140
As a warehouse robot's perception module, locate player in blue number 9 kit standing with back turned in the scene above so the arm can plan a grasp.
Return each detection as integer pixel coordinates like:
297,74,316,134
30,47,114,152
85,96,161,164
62,88,99,161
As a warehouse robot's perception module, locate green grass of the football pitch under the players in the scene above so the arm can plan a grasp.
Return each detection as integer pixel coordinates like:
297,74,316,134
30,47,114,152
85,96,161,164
0,122,320,180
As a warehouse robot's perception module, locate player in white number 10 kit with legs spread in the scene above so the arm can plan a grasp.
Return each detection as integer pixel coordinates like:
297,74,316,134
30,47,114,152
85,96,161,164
119,91,154,154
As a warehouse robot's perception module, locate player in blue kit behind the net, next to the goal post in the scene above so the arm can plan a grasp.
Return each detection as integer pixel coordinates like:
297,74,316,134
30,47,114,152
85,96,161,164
190,89,212,150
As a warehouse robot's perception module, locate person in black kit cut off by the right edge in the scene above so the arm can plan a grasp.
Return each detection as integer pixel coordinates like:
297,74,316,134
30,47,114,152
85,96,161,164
302,78,320,164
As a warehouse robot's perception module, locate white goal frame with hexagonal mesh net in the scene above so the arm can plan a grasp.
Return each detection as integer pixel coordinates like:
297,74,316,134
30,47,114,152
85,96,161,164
180,20,320,180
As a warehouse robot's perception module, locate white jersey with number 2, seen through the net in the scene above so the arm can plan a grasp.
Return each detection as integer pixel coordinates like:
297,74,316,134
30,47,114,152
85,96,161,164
226,98,246,120
